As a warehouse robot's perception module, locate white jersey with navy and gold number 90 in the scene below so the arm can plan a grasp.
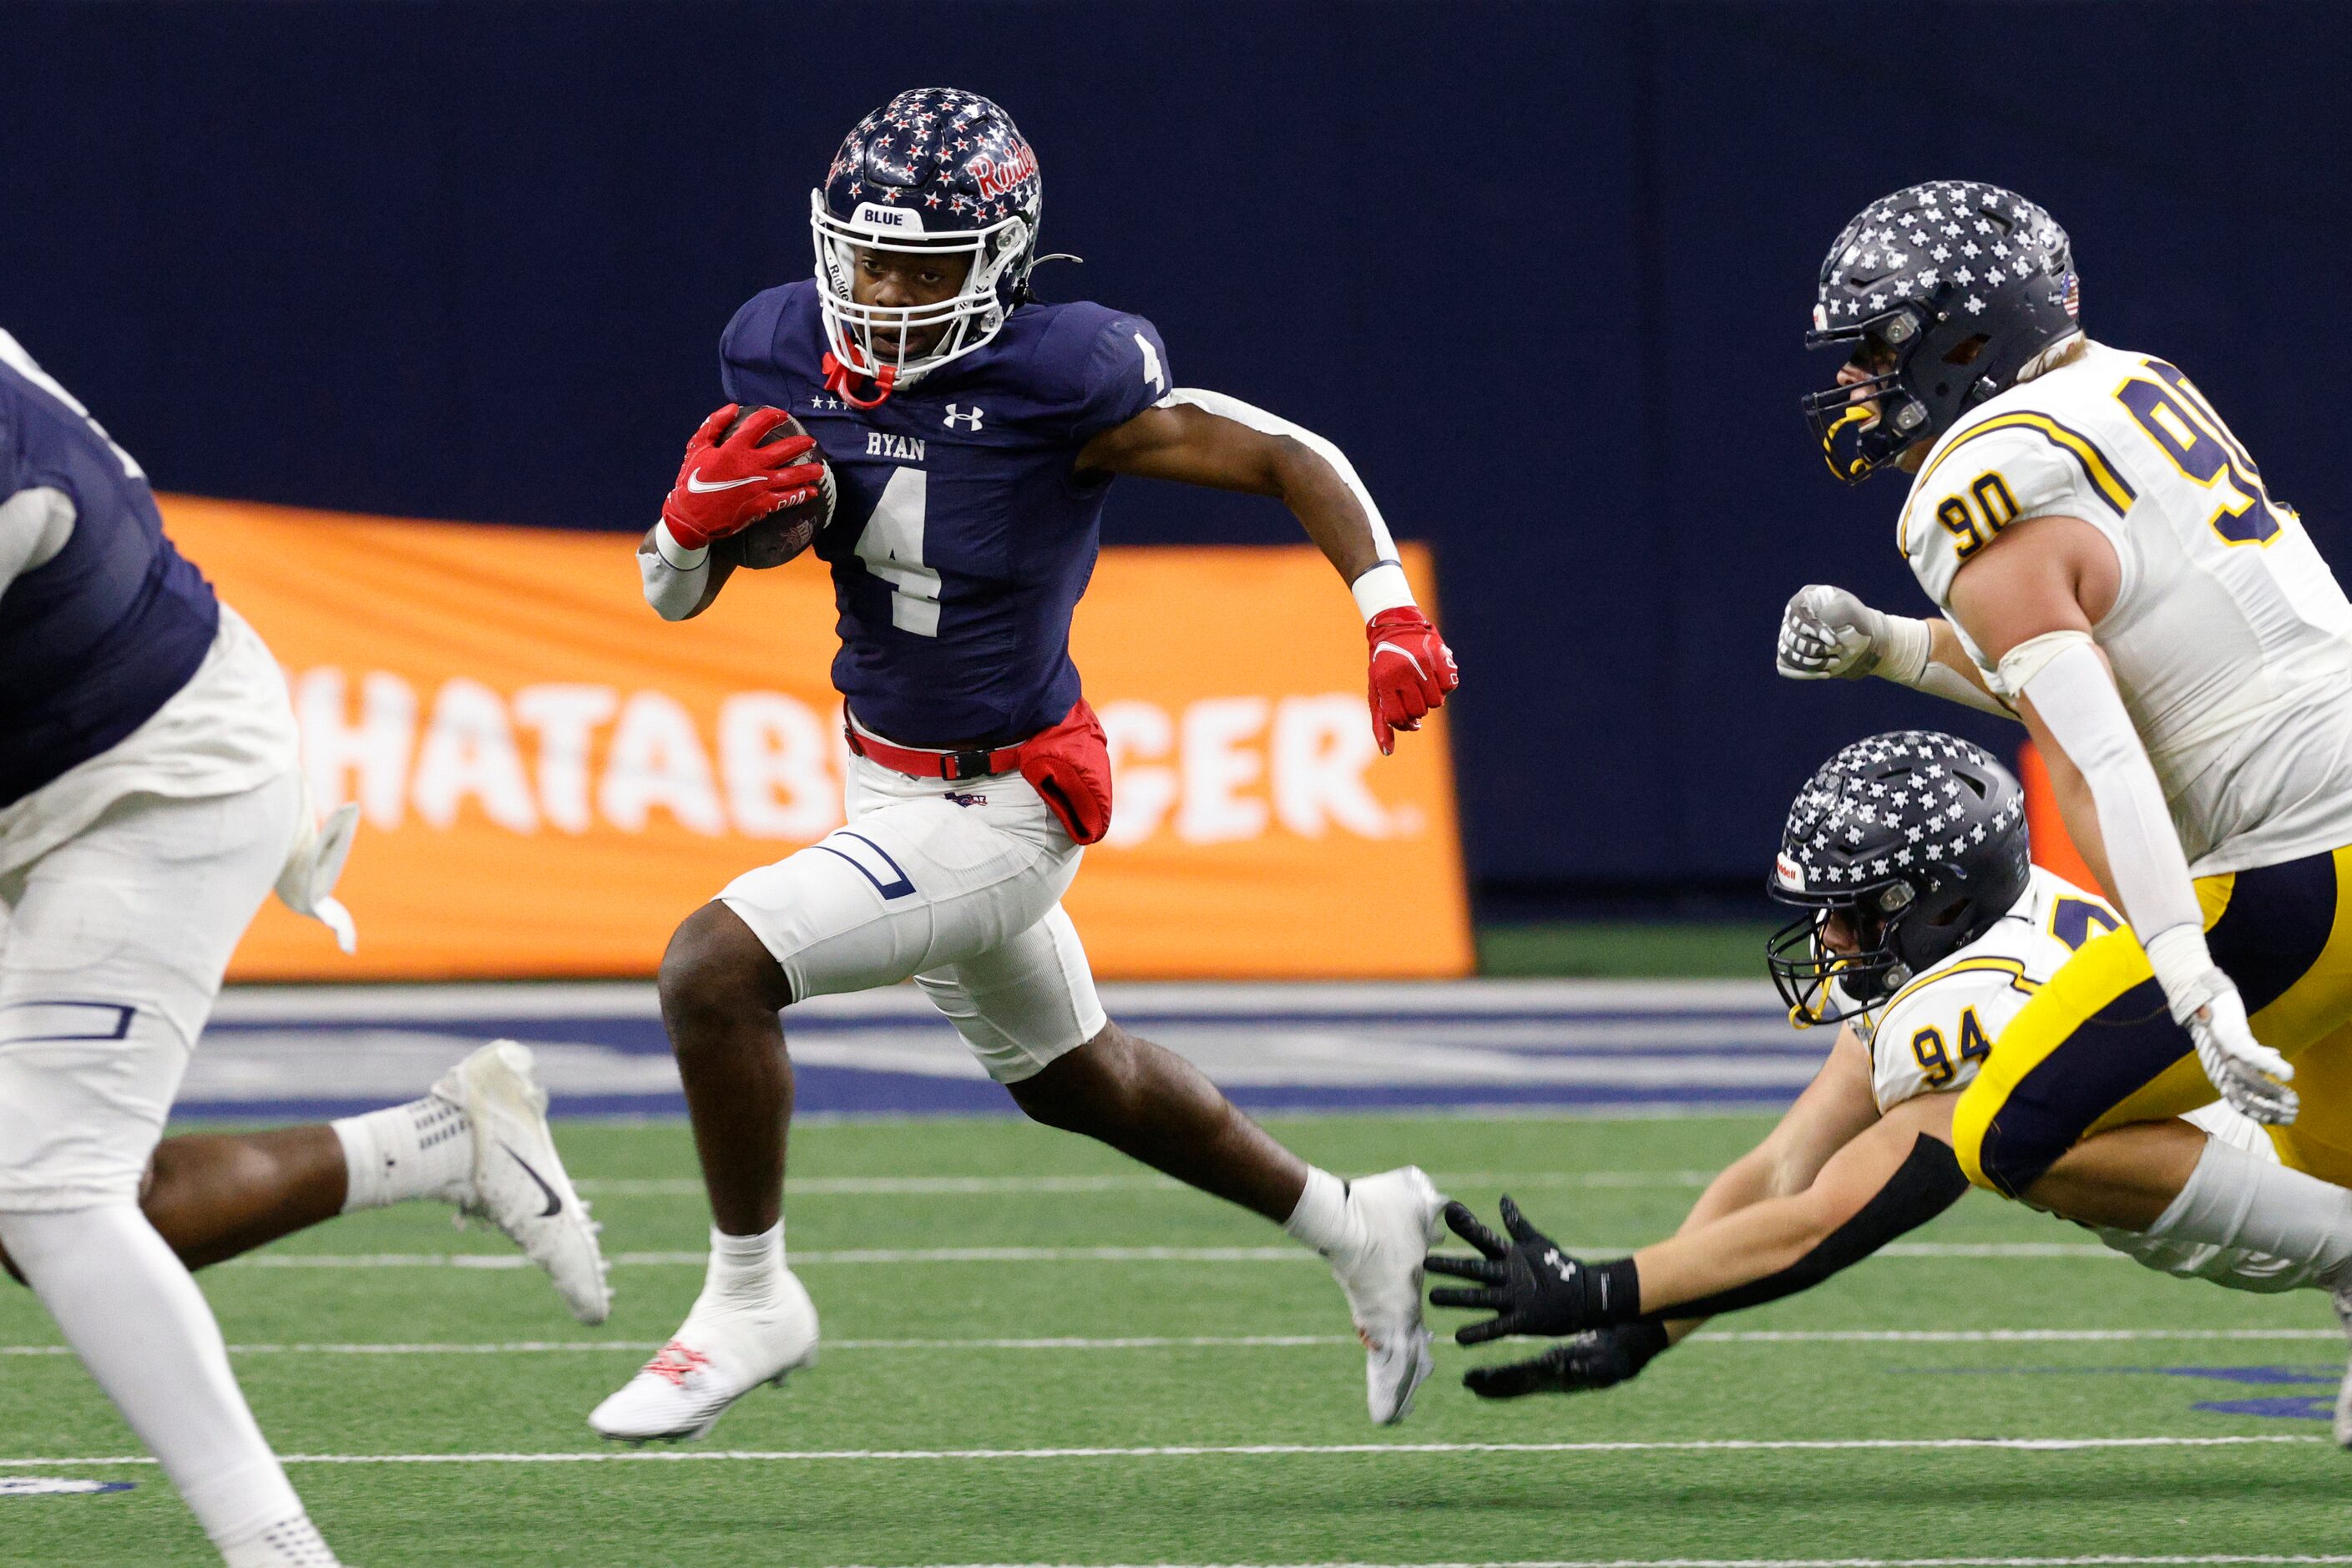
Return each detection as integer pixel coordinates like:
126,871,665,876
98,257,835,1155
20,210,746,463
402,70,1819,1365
1900,343,2352,877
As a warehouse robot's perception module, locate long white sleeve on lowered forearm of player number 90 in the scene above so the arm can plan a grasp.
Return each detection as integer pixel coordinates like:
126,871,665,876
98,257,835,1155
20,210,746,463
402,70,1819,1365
2001,632,2213,959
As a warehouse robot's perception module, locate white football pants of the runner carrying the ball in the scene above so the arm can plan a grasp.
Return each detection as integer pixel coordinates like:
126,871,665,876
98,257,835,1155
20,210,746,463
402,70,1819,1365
720,757,1108,1084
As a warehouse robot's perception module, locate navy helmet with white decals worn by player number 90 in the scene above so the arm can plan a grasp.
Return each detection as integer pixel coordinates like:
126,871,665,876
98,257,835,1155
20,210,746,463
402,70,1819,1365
1804,179,2081,484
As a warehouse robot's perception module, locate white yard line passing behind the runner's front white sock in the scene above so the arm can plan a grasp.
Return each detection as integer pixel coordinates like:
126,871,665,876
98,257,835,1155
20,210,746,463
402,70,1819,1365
219,1242,2122,1269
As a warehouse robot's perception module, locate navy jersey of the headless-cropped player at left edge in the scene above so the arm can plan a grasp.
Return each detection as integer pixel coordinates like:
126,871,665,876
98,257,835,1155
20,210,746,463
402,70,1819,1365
0,331,221,807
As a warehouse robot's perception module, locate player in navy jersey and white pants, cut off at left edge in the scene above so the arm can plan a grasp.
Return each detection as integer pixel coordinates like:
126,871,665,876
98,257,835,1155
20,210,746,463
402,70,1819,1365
0,331,607,1568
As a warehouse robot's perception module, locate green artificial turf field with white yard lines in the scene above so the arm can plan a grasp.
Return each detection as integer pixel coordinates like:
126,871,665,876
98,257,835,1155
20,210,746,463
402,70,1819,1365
0,1116,2352,1568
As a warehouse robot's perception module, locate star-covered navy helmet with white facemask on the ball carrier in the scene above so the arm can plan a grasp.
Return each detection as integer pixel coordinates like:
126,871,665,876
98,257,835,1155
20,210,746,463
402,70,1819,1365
809,87,1044,407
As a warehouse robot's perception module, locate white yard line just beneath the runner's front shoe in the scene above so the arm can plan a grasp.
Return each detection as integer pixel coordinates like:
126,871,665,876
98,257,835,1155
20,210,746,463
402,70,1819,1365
0,1434,2329,1476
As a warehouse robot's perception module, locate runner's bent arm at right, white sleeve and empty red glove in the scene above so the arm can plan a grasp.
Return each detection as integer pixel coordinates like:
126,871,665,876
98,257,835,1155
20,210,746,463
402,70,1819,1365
1077,388,1460,755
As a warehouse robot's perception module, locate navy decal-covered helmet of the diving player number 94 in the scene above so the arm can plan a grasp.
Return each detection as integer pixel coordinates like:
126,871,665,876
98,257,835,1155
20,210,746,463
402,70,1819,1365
1764,729,2032,1025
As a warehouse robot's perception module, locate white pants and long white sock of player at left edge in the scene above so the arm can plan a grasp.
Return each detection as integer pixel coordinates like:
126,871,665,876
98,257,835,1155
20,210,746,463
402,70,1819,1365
0,771,317,1561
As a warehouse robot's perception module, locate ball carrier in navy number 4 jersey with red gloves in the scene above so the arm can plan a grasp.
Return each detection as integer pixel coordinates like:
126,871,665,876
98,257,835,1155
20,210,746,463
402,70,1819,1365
590,89,1456,1441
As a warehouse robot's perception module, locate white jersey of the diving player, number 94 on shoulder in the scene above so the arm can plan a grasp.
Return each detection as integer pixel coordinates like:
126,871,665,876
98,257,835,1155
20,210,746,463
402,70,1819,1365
1846,865,2124,1115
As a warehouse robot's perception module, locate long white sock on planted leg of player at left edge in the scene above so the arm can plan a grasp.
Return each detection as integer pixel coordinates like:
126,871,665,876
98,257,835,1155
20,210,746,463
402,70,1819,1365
0,1204,334,1561
